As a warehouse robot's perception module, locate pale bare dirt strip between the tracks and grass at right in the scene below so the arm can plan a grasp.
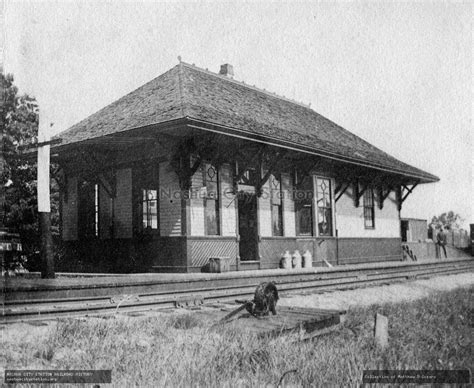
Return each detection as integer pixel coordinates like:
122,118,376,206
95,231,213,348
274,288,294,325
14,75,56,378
278,272,474,309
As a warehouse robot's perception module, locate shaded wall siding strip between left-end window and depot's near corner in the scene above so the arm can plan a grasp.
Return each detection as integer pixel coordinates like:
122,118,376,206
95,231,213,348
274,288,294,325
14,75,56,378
158,162,181,236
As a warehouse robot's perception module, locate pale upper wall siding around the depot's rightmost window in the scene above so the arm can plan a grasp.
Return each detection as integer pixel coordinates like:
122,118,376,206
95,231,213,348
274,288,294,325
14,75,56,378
336,187,400,238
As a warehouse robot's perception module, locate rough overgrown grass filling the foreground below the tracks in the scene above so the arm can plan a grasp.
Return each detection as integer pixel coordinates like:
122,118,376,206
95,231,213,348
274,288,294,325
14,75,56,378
2,288,474,387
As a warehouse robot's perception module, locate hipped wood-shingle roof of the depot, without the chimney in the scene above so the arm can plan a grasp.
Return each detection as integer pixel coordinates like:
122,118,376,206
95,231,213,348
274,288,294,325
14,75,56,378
57,62,439,182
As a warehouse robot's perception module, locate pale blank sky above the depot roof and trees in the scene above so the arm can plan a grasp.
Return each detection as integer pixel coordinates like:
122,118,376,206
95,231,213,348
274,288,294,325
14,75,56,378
2,0,474,226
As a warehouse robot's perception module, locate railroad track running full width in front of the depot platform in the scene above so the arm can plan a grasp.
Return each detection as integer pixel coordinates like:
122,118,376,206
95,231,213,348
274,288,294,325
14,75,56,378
1,259,474,323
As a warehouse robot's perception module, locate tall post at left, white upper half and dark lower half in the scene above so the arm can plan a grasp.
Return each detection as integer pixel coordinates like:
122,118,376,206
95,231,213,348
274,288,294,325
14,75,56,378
37,114,55,279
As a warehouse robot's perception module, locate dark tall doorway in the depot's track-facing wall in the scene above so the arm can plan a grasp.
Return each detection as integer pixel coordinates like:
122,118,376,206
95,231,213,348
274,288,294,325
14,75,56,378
238,193,259,261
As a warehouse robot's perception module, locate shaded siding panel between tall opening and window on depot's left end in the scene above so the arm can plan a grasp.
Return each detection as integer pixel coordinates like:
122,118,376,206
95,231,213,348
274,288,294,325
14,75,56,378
114,168,133,238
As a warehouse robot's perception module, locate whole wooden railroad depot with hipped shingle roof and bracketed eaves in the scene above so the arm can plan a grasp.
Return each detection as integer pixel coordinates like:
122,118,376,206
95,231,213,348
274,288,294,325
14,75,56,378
51,62,438,272
